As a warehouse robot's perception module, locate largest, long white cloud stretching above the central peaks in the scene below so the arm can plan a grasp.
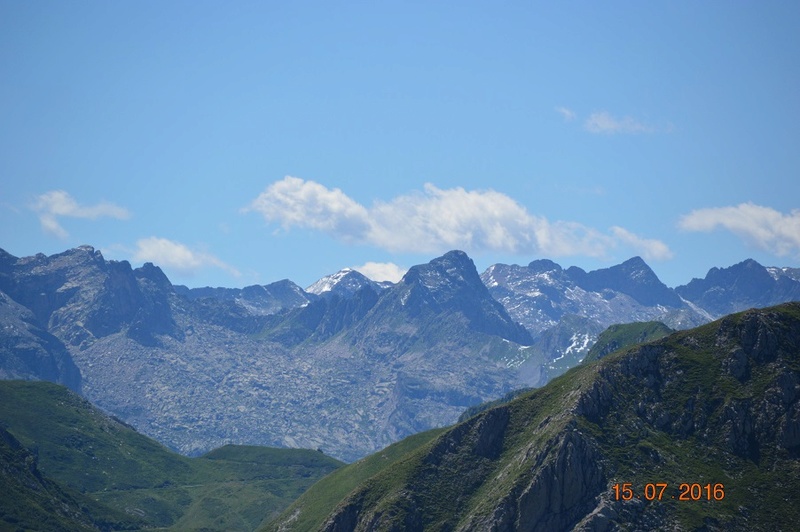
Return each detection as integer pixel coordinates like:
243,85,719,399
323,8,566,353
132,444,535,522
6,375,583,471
244,177,668,258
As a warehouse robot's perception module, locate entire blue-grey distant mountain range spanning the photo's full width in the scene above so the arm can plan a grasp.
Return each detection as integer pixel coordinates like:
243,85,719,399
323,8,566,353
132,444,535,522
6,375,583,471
0,246,800,461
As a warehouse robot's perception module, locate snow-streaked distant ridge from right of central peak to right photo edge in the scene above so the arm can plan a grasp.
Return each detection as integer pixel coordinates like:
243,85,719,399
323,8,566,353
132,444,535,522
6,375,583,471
481,257,800,385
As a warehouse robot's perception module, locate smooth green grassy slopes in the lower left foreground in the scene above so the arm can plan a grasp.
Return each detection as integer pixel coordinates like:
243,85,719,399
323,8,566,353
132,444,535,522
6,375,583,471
0,381,342,530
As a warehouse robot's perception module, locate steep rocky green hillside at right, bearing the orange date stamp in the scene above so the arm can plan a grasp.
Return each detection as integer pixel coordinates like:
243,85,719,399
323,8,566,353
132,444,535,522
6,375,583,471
270,303,800,531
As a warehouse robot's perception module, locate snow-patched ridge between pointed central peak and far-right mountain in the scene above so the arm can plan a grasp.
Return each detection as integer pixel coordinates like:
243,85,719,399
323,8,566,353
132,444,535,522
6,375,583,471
481,257,711,386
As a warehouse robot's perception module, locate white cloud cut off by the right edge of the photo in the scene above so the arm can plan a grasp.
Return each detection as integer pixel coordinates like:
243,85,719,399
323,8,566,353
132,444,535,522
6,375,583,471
678,202,800,256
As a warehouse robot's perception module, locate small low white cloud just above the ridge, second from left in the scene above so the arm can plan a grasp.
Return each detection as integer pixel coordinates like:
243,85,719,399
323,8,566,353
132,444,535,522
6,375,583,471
133,236,241,277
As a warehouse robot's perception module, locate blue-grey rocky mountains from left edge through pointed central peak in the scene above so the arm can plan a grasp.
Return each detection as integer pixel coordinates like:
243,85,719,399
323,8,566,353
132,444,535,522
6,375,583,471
0,246,528,460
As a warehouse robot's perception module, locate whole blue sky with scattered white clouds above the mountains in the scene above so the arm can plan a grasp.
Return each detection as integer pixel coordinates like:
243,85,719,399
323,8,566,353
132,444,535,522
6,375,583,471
0,0,800,287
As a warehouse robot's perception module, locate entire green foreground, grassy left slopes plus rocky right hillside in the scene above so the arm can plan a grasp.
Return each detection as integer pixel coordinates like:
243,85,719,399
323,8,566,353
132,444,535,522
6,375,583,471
6,302,800,531
